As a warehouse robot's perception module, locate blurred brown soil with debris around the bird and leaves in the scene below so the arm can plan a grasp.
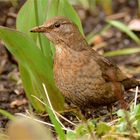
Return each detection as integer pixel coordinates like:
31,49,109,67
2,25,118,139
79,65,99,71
0,0,140,127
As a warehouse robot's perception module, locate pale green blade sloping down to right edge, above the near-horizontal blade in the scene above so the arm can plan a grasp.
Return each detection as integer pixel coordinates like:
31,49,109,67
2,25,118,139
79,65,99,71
107,20,140,45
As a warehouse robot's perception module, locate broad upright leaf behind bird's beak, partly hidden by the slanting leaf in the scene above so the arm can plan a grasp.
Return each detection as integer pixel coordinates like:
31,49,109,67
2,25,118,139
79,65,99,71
17,0,63,110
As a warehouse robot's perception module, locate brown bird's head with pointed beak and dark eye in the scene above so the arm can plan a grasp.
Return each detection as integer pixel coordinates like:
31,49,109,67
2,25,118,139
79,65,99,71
31,16,83,45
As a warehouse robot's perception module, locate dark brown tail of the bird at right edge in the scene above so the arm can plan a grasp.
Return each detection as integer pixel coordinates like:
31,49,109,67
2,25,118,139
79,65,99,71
121,78,140,90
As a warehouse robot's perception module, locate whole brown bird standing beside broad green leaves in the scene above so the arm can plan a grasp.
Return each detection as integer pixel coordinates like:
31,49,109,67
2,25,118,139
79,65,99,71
31,16,140,109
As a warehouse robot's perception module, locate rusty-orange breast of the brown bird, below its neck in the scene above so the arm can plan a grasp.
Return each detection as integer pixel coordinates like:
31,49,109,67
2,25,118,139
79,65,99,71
54,47,87,88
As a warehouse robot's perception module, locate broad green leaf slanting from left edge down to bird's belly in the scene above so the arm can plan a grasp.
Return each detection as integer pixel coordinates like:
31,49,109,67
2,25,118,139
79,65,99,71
0,27,63,110
